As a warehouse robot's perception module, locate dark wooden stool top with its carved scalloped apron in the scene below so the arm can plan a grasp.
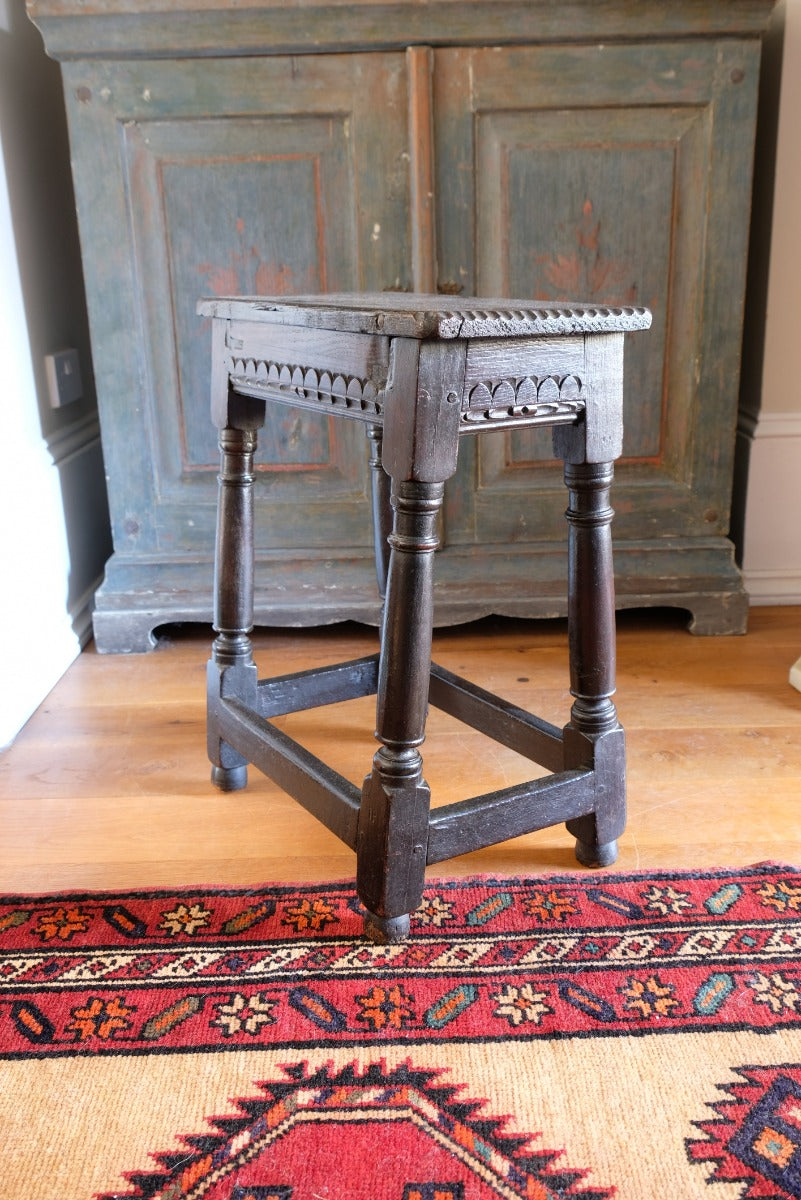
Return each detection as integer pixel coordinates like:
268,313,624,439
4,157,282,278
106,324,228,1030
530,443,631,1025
198,292,651,479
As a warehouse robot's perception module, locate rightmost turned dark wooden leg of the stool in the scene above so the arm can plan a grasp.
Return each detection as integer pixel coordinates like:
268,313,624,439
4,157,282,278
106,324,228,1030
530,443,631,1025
565,462,626,866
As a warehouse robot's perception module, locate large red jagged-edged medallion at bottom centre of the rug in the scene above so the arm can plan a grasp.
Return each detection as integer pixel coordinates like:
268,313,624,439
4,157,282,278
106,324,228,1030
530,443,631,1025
101,1064,614,1200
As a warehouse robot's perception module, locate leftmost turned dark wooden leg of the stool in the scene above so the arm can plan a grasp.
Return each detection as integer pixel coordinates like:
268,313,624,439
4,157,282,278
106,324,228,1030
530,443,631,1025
207,428,257,792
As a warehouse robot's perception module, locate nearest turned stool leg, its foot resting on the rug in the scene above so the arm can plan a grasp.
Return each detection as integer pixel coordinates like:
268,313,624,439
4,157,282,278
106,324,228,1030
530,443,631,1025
356,480,445,942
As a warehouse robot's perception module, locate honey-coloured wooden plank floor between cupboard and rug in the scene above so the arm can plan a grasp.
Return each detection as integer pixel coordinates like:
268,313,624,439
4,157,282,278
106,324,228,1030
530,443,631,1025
0,608,801,892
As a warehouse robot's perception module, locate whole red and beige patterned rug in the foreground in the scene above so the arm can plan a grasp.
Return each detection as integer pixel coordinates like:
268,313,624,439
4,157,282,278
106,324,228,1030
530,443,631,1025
0,864,801,1200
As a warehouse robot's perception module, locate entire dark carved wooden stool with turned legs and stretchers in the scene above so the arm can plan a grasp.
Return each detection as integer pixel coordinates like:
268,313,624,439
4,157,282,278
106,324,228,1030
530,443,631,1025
199,293,651,942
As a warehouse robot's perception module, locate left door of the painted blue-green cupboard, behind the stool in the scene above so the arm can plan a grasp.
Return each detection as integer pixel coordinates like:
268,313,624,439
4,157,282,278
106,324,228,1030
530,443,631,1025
65,54,410,561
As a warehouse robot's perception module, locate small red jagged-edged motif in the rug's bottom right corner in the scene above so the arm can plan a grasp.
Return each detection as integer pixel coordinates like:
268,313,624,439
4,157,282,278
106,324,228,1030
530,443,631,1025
687,1063,801,1200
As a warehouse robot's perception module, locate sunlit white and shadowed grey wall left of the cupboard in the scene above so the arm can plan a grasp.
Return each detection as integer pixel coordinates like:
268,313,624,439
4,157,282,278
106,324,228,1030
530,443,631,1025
0,0,110,746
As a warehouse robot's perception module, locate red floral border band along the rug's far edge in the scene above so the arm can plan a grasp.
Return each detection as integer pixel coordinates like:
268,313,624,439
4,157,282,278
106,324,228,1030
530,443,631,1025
0,865,801,1058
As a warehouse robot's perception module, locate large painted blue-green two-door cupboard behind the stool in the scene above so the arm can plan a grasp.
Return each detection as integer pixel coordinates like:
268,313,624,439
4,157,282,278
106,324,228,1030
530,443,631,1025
28,0,772,652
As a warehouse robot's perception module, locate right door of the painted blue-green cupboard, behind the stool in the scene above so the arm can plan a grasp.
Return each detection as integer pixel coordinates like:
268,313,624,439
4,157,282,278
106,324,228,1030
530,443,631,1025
434,41,759,554
